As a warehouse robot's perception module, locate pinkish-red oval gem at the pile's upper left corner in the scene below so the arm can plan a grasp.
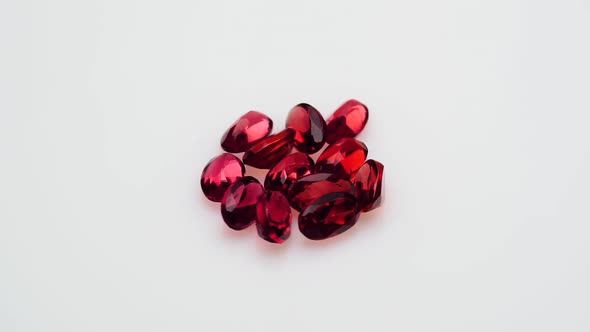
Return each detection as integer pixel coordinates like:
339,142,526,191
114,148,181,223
221,111,272,153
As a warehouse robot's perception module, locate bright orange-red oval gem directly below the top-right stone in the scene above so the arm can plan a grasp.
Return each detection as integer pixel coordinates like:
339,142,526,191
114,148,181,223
315,138,368,178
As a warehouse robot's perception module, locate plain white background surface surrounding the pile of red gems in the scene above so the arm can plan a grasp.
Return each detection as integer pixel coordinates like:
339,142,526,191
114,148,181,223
0,0,590,332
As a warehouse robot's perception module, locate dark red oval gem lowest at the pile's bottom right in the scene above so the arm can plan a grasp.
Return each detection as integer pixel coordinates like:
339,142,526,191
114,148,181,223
299,192,359,240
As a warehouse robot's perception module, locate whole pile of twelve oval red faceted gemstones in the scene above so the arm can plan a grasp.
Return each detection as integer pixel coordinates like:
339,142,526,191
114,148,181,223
201,100,383,243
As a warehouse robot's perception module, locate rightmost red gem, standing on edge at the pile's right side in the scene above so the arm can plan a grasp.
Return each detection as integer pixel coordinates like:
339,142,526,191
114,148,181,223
353,159,383,212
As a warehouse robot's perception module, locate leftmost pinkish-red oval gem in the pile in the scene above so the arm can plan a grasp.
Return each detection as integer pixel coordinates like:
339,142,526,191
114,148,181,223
201,153,245,202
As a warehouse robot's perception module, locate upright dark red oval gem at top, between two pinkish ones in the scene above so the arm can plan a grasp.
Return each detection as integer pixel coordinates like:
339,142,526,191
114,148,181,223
285,103,326,154
